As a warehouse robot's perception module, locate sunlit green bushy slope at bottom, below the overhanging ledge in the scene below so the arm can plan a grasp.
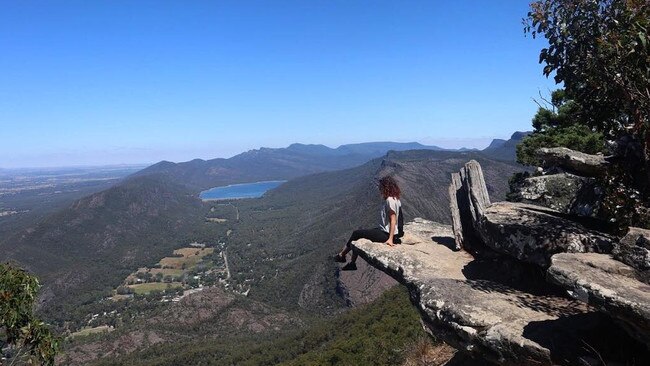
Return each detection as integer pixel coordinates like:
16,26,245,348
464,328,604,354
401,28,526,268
87,286,426,365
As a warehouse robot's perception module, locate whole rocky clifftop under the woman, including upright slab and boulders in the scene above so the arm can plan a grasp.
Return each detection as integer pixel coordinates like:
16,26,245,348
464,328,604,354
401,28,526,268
354,151,650,365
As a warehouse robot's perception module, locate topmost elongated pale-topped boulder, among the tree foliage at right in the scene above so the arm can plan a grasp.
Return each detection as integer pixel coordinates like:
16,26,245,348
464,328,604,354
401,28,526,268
537,147,607,177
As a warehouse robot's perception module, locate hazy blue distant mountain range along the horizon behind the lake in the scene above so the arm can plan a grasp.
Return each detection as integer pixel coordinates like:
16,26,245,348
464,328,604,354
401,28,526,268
134,132,527,191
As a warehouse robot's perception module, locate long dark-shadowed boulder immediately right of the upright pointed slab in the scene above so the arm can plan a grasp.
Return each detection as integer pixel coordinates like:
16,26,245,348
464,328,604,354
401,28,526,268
477,202,614,268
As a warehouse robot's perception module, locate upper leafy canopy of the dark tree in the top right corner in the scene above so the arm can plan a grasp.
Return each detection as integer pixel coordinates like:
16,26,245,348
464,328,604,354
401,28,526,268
525,0,650,142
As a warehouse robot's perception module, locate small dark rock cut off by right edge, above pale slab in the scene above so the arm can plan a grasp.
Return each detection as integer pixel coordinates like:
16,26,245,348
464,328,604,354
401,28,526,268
612,227,650,283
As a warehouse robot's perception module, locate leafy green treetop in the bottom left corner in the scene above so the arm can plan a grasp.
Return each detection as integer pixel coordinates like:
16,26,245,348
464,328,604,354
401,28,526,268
0,264,58,365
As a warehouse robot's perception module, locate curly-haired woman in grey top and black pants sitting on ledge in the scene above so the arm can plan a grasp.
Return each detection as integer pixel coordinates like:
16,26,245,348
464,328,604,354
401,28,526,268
334,176,402,271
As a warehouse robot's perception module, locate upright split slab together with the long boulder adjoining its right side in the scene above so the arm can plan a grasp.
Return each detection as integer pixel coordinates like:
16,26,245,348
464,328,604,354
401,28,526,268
450,161,612,268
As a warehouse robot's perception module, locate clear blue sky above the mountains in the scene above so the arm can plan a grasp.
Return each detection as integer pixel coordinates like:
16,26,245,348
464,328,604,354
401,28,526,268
0,0,553,168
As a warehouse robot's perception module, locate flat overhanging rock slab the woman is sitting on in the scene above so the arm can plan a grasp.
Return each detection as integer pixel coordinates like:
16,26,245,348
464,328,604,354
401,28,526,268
353,219,602,365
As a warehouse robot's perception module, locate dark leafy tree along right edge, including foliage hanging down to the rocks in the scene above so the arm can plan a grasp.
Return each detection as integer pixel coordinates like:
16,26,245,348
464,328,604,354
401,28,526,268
523,0,650,229
